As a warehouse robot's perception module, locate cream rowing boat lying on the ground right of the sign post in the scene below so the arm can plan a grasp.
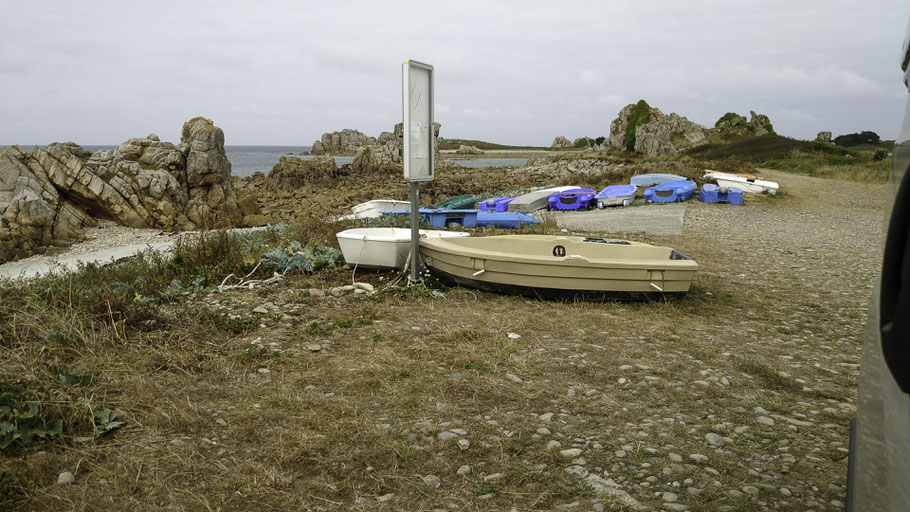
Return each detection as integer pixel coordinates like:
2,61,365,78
420,235,698,298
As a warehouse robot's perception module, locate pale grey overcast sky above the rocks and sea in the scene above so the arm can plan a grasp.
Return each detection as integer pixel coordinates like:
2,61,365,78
0,0,910,145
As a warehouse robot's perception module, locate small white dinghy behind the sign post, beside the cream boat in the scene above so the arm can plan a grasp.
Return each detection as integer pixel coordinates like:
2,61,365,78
335,228,470,269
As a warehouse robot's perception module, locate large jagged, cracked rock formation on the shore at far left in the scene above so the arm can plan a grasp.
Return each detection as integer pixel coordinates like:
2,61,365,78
0,118,262,262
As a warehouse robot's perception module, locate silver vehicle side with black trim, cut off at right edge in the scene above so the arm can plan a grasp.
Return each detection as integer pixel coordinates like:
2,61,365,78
847,18,910,512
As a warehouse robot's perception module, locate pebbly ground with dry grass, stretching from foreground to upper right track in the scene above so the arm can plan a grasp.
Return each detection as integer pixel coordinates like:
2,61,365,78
7,170,885,511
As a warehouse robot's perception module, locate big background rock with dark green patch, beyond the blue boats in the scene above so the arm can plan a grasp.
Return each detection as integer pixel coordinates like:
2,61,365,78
609,100,708,156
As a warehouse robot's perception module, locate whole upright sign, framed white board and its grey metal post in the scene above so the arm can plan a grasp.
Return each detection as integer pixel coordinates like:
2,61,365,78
401,59,436,283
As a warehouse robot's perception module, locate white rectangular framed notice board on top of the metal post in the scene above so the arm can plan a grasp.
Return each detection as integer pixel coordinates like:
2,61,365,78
401,59,435,181
